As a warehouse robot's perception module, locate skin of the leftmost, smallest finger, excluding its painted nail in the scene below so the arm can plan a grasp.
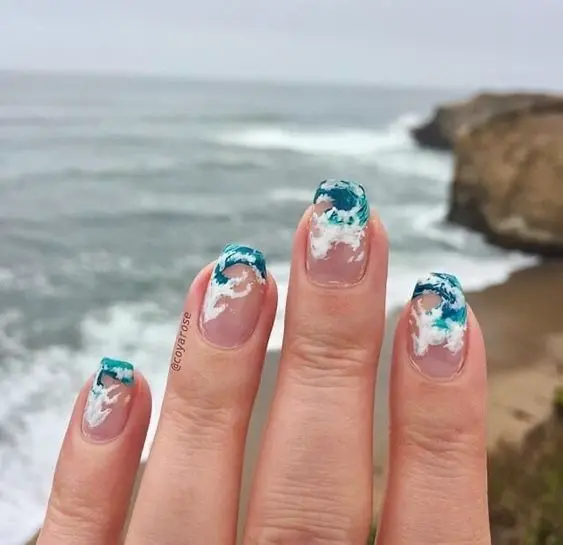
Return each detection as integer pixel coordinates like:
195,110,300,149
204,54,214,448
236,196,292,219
37,372,151,545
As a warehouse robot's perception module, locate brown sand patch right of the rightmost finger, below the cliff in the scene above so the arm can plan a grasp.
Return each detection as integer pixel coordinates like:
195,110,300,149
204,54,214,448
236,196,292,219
468,261,563,448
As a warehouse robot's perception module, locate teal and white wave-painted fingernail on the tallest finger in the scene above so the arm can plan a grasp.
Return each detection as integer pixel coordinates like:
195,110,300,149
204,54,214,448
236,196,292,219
307,180,369,285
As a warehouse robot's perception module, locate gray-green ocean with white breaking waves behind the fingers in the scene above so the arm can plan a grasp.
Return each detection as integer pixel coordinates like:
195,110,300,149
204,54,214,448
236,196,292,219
0,74,532,545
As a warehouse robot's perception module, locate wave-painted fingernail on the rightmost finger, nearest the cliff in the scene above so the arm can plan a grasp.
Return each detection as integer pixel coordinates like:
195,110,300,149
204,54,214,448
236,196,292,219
409,273,467,378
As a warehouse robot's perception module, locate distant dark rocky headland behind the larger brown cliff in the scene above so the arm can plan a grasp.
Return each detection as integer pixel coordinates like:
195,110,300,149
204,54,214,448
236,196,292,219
412,93,563,150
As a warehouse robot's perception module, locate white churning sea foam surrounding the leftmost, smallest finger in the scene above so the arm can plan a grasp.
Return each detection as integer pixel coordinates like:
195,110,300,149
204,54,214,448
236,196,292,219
0,305,174,545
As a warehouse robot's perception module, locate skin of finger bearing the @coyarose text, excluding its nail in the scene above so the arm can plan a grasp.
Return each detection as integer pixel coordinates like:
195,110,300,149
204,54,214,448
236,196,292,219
126,265,277,545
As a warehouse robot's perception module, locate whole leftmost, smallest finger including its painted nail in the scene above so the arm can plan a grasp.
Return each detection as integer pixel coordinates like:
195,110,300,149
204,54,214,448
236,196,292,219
38,358,151,545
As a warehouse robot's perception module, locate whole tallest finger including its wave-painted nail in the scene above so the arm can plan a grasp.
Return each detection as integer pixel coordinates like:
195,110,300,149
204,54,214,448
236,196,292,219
244,182,388,545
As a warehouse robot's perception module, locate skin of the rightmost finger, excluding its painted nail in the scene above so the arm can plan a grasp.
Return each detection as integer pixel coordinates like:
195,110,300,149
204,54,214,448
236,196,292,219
377,310,491,545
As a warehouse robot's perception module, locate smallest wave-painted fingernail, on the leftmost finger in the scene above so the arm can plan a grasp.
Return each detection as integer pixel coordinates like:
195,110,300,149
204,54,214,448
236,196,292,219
82,358,135,442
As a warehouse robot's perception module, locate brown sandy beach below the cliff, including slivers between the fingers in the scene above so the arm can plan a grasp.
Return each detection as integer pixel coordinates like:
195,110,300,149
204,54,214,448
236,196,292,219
23,261,563,545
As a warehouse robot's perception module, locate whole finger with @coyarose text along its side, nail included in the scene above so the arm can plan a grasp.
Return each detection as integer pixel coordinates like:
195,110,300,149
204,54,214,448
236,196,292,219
126,245,276,545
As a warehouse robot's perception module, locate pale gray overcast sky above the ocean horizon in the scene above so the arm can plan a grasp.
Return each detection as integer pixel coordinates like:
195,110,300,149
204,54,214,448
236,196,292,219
0,0,563,89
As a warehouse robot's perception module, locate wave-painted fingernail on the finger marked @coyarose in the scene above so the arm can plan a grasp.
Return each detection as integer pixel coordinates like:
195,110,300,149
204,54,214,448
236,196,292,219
200,244,266,348
